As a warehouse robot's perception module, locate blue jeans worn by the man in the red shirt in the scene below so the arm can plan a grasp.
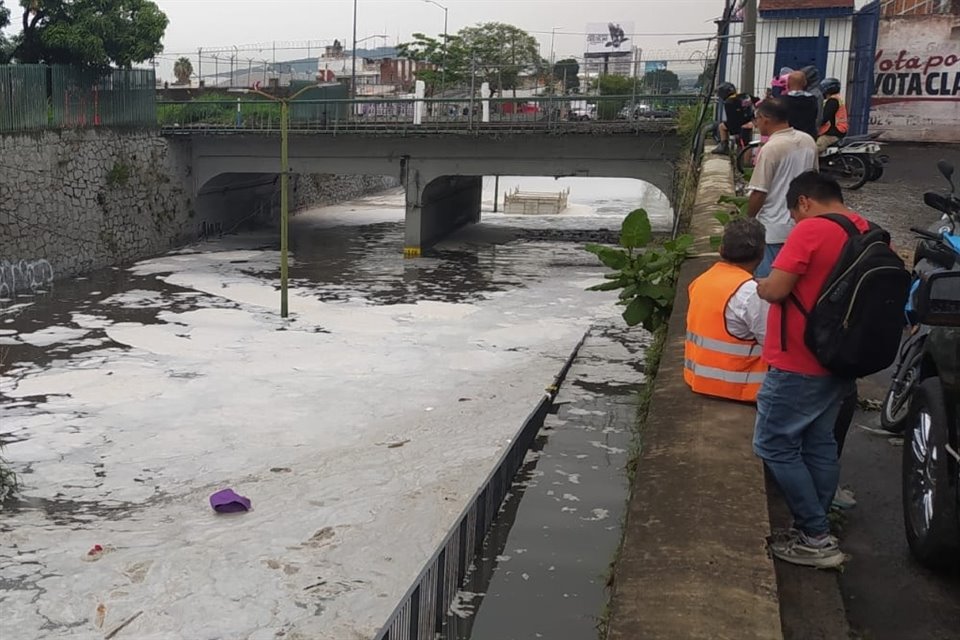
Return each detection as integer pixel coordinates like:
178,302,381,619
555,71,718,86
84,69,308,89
753,368,853,536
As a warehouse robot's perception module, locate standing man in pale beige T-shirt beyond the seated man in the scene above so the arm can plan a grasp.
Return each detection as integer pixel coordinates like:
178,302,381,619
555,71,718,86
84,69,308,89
747,98,818,278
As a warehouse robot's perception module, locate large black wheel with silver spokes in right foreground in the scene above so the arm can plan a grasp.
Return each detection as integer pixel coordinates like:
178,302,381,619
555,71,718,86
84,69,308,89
901,378,960,569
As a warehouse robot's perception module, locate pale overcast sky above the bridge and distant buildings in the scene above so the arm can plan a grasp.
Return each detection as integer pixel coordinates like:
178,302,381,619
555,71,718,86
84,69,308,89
155,0,723,58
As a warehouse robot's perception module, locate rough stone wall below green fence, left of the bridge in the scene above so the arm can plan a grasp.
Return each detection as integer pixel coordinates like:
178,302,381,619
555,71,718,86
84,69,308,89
0,130,192,289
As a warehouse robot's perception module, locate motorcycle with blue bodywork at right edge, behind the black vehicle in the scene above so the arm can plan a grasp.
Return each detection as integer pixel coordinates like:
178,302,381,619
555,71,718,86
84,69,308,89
880,160,960,433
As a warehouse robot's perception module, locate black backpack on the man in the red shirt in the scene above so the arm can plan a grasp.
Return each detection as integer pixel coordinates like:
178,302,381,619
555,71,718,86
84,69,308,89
780,213,911,378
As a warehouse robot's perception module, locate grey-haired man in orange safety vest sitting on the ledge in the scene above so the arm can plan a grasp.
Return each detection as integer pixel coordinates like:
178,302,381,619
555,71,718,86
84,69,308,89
683,218,769,402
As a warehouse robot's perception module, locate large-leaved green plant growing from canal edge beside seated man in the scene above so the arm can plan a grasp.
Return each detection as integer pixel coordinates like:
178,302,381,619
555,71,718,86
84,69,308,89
586,209,693,331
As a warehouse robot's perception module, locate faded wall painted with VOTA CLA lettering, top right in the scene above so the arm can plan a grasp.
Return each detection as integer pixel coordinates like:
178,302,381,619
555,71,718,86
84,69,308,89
870,16,960,142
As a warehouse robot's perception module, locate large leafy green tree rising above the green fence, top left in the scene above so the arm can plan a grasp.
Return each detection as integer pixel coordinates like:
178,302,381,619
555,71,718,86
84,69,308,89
13,0,168,69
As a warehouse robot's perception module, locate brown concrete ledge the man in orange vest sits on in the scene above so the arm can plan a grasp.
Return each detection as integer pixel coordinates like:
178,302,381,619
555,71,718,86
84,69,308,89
608,157,782,640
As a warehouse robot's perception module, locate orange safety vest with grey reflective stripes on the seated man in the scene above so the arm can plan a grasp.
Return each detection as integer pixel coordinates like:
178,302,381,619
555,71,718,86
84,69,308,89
683,262,767,402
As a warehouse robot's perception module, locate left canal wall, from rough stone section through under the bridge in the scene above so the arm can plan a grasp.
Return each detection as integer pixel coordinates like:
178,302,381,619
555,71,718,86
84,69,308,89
0,129,399,296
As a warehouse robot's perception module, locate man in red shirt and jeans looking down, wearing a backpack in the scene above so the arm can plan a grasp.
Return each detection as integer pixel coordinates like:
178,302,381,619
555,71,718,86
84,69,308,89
753,171,868,567
